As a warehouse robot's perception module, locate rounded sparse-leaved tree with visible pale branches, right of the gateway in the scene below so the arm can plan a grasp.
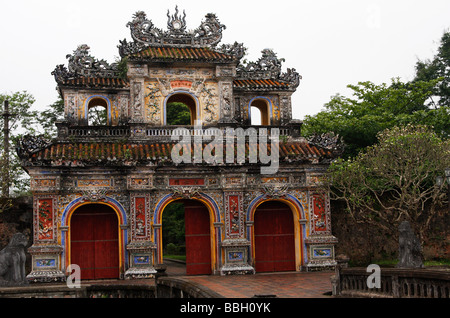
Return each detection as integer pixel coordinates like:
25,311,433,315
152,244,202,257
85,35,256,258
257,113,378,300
327,125,450,238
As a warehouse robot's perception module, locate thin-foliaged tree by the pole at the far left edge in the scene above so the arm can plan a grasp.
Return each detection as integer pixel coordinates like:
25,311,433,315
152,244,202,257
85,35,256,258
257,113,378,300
0,91,38,195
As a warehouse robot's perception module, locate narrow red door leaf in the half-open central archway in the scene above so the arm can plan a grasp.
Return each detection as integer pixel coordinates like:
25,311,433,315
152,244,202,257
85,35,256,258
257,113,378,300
184,201,211,275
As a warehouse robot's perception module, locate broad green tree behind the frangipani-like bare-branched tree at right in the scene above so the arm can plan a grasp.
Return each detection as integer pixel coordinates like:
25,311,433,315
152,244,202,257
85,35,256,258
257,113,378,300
303,79,450,157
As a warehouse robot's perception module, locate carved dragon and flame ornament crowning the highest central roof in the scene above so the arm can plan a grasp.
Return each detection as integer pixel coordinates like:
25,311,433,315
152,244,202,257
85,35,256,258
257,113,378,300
119,6,226,57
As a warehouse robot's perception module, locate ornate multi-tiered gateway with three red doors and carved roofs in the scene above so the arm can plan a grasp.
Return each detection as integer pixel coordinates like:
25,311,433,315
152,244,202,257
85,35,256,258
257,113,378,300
18,8,337,282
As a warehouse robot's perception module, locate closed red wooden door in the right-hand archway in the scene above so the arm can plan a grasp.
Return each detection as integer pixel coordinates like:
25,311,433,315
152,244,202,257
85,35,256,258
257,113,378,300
254,201,295,272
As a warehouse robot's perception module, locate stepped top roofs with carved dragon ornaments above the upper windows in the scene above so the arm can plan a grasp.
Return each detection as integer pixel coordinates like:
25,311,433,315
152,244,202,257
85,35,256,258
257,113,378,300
52,7,301,91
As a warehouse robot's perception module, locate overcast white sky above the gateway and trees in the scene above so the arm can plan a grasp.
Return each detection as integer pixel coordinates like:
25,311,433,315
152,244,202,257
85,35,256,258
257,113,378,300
0,0,450,119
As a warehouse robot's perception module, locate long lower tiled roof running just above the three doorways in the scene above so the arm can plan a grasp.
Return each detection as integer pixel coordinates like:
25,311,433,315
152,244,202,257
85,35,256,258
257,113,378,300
28,142,333,165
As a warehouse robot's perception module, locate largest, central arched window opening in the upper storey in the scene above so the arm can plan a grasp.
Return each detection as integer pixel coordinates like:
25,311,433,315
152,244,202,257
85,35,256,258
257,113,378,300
166,94,197,125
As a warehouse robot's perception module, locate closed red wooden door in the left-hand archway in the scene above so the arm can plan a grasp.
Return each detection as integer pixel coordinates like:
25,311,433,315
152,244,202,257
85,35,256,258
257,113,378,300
70,204,119,279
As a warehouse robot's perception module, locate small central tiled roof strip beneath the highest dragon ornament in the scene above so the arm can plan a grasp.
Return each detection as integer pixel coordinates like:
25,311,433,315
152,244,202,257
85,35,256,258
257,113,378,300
129,47,235,61
